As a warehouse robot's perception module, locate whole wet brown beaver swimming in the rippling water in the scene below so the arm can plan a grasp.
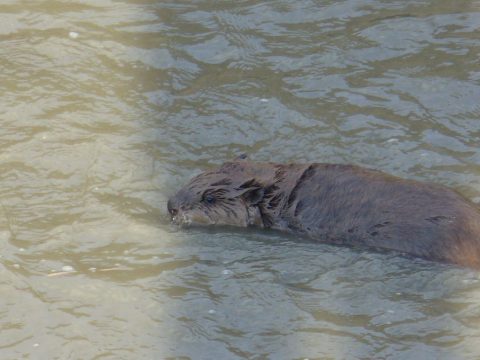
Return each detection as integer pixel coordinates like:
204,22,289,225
168,157,480,268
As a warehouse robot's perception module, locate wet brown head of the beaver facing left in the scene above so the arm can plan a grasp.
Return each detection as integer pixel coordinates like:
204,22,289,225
167,156,271,226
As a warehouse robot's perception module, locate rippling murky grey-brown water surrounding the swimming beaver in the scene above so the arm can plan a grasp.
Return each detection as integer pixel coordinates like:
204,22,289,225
0,0,480,359
